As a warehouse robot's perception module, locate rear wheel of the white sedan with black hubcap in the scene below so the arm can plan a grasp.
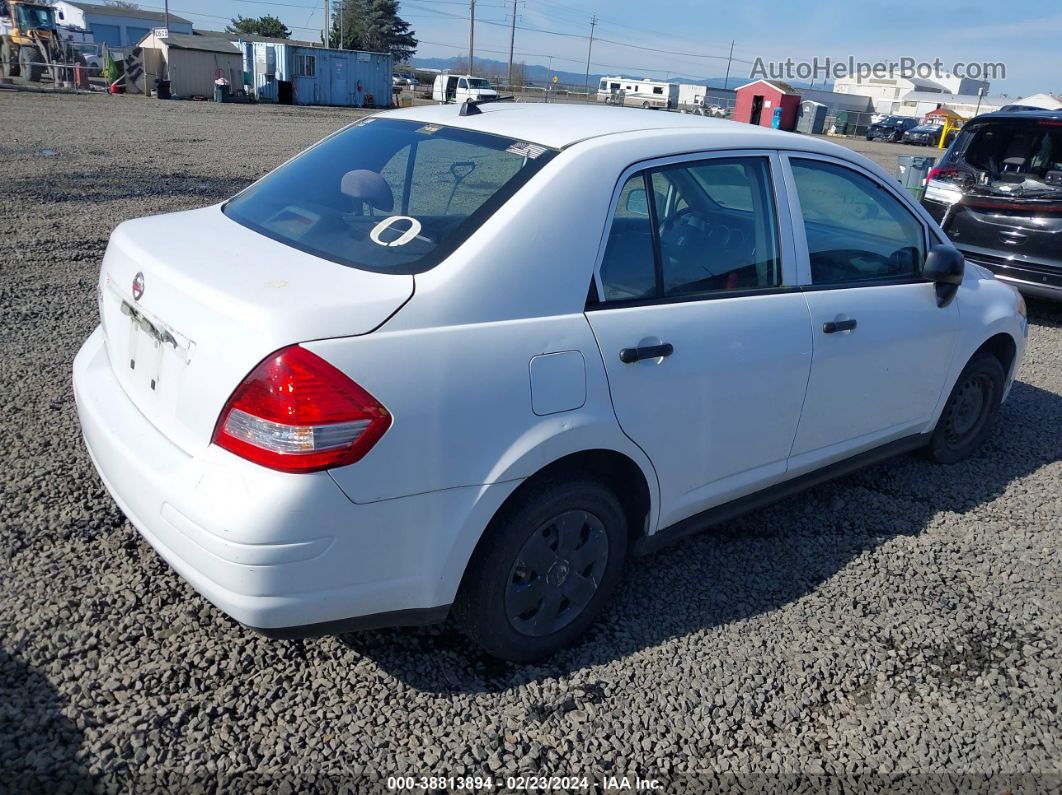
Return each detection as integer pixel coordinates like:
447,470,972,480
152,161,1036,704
453,472,627,662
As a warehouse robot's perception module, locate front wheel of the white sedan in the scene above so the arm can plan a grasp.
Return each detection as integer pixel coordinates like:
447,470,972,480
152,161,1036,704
926,351,1007,464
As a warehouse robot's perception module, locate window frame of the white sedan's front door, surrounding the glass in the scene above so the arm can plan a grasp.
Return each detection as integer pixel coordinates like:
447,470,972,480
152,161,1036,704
778,150,947,291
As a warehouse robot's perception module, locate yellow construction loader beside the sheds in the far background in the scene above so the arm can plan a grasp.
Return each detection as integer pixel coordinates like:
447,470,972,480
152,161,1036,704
0,0,76,83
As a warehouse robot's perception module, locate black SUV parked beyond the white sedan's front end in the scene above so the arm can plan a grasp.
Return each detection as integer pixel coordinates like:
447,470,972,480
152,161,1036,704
922,110,1062,300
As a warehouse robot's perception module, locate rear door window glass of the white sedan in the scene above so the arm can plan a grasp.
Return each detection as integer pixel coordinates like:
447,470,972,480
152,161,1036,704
601,157,782,301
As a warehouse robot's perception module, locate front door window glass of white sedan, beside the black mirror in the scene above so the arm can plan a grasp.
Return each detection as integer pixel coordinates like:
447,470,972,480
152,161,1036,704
790,158,925,284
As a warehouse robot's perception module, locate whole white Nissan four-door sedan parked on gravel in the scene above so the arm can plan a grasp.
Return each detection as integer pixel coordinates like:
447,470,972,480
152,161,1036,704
73,102,1026,661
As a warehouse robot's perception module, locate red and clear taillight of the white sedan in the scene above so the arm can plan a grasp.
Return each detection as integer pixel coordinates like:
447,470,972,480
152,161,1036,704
212,345,391,472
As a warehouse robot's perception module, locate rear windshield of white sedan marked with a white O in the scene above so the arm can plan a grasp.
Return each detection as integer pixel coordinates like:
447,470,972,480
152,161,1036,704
223,118,555,274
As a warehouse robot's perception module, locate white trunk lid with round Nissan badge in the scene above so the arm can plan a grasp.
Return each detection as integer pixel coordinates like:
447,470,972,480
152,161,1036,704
98,201,413,453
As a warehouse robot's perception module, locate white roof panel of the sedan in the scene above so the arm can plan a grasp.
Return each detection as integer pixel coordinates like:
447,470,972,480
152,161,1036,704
381,102,801,149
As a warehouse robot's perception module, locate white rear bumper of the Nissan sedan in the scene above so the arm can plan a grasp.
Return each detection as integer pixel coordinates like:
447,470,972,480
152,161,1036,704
73,329,508,637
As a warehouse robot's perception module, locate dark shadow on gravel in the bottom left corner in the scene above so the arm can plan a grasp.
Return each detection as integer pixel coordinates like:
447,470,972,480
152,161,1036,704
0,650,92,793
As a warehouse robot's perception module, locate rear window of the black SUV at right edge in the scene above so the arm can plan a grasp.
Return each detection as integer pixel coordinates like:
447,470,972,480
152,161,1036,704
949,120,1062,179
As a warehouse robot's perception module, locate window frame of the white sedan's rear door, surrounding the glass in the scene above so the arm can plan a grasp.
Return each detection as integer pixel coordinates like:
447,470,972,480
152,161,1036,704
586,149,807,311
